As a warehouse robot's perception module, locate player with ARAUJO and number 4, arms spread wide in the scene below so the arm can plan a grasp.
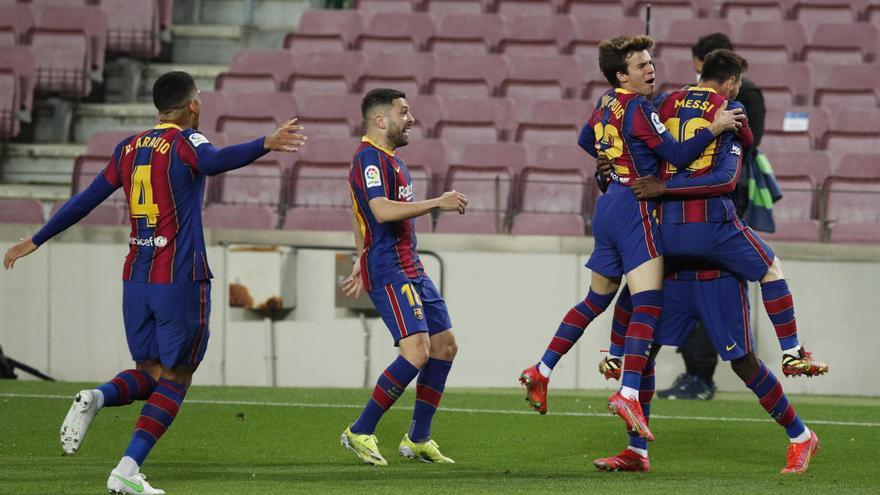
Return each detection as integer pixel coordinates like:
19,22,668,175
3,72,306,495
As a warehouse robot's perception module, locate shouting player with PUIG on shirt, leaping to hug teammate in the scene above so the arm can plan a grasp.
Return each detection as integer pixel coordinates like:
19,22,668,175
520,36,741,438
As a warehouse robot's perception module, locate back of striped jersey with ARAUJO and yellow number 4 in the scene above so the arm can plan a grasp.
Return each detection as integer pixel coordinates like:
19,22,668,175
104,124,211,283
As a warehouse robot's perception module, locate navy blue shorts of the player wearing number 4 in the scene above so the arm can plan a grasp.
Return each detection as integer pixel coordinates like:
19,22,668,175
122,280,211,368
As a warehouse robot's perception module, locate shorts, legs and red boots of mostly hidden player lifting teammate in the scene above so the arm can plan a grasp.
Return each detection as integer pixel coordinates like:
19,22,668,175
593,264,819,474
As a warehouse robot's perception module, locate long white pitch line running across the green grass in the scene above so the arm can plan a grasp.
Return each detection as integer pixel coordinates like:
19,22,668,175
0,393,880,428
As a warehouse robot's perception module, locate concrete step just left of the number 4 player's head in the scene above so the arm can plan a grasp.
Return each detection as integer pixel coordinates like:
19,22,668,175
73,103,159,144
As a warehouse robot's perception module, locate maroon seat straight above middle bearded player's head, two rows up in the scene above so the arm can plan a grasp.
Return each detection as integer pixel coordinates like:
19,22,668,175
354,11,434,53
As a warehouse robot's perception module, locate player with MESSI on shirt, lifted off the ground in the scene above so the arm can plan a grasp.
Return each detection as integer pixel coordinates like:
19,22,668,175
632,49,828,376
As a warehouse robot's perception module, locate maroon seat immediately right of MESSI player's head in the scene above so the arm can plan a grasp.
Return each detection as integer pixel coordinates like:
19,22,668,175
746,62,813,106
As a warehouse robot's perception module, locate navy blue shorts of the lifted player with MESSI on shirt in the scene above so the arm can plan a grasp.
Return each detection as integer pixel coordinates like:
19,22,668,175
660,219,776,282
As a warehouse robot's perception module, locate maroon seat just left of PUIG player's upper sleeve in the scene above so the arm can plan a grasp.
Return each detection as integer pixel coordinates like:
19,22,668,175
515,100,595,145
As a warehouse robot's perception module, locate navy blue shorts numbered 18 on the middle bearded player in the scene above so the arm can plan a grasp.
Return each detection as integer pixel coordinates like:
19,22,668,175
370,273,452,346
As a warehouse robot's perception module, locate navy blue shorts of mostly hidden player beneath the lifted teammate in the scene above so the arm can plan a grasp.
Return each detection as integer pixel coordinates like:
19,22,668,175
654,276,755,361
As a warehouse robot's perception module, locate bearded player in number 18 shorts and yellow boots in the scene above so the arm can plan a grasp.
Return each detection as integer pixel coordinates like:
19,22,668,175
341,88,468,466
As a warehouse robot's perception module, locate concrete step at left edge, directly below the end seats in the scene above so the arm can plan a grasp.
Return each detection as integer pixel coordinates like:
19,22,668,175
0,143,86,187
